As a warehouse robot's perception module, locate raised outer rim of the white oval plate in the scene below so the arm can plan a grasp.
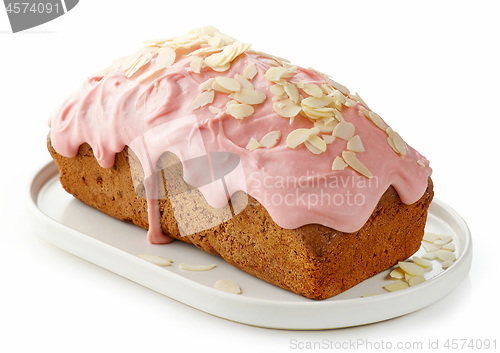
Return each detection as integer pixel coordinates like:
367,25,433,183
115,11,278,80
24,160,472,330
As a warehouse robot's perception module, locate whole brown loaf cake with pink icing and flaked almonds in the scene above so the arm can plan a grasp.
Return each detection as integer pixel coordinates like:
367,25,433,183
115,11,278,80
48,26,433,299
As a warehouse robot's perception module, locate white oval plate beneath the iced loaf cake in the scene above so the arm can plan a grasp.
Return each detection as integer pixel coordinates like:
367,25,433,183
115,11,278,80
26,162,472,330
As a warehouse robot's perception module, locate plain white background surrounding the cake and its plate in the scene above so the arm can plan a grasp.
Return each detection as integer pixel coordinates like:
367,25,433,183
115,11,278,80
0,0,500,352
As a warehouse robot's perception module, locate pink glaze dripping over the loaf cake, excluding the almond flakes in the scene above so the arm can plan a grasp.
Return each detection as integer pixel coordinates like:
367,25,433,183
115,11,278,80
49,48,432,243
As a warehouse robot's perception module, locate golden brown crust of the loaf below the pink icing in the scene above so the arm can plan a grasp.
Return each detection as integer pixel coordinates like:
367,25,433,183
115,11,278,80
47,138,433,299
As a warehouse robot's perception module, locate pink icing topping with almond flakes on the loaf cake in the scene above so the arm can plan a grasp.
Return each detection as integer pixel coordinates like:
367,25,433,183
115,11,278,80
49,26,432,243
